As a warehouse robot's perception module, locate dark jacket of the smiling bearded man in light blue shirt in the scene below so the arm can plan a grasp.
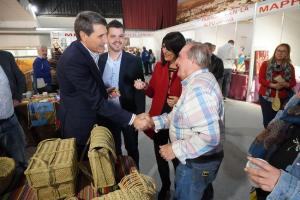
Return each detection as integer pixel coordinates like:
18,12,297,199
99,51,145,114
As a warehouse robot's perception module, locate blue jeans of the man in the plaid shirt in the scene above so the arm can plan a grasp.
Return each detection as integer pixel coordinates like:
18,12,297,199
175,159,222,200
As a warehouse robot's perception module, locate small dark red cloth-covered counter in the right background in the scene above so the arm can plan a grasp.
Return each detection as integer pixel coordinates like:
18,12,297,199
229,73,248,100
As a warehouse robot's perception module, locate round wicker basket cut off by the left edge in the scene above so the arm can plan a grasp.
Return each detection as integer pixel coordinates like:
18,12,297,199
0,157,16,194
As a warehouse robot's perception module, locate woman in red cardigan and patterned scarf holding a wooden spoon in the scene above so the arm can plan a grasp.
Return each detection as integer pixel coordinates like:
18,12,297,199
259,43,296,128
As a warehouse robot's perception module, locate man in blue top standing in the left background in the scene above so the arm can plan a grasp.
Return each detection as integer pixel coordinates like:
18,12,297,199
33,46,51,93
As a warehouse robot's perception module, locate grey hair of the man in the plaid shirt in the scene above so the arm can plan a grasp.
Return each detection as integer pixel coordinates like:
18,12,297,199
187,42,210,68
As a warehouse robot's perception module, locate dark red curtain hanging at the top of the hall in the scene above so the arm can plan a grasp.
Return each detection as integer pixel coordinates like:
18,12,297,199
122,0,177,30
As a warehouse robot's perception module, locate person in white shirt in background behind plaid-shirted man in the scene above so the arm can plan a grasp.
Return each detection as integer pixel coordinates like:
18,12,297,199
217,40,237,99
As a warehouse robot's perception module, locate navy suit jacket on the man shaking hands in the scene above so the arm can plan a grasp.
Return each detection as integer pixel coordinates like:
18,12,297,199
57,41,132,145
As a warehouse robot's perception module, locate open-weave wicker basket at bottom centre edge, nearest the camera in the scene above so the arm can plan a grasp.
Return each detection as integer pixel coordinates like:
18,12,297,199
93,170,156,200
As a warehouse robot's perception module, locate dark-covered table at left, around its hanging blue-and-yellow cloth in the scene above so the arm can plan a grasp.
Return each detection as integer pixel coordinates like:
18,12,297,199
15,96,60,146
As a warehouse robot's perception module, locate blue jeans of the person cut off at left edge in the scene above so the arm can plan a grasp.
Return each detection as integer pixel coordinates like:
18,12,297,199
0,114,27,171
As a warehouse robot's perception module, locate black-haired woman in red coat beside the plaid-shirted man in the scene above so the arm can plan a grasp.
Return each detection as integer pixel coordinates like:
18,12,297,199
134,32,186,199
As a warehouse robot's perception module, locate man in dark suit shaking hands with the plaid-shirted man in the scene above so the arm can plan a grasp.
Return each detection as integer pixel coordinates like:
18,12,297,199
57,11,147,153
